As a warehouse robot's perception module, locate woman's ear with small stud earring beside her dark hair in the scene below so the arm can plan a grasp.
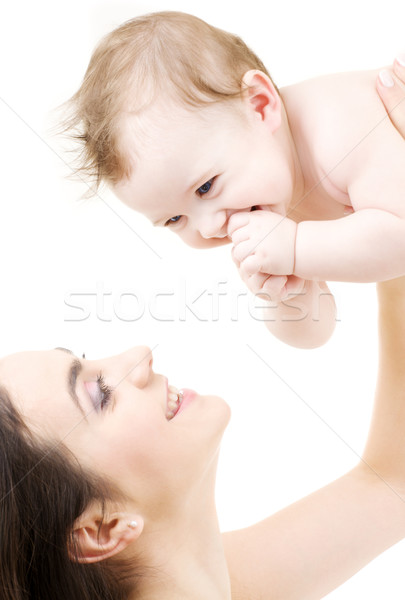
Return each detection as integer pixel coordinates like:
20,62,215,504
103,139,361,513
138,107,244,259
68,507,144,563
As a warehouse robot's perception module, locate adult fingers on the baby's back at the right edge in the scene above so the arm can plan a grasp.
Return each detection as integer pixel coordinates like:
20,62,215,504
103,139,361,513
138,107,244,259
377,53,405,138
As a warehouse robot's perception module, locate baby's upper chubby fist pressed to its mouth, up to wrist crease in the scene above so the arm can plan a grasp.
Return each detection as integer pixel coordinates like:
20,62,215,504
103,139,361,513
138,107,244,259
228,210,297,280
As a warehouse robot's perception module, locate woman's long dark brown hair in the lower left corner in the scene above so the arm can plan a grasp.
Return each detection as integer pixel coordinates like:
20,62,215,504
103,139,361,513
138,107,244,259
0,388,137,600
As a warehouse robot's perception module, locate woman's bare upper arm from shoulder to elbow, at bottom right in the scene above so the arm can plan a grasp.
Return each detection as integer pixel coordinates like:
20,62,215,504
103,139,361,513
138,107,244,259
224,463,405,600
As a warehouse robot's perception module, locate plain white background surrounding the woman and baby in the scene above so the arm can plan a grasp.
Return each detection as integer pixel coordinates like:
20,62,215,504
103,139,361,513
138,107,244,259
0,0,405,600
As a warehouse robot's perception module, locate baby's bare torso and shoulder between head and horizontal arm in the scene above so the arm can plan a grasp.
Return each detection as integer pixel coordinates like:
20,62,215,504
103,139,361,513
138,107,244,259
281,70,405,221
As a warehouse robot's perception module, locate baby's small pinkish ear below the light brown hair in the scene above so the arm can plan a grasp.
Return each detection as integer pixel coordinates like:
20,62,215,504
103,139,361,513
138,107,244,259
242,69,282,132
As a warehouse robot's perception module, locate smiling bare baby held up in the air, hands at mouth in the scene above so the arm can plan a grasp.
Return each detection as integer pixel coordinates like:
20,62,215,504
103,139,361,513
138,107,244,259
64,12,405,347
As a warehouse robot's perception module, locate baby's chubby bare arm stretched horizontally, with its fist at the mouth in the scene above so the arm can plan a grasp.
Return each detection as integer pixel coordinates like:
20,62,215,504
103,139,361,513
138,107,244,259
229,203,405,283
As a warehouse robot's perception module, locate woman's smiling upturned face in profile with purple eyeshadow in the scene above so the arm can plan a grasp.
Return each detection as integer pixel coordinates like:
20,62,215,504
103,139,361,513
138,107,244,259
0,346,229,511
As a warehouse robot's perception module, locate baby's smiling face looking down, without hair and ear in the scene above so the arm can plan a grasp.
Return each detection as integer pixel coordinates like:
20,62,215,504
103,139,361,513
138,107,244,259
114,102,293,248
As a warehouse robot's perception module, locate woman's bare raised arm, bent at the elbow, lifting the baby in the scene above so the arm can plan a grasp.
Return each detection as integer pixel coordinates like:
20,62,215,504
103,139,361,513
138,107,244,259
226,277,405,600
